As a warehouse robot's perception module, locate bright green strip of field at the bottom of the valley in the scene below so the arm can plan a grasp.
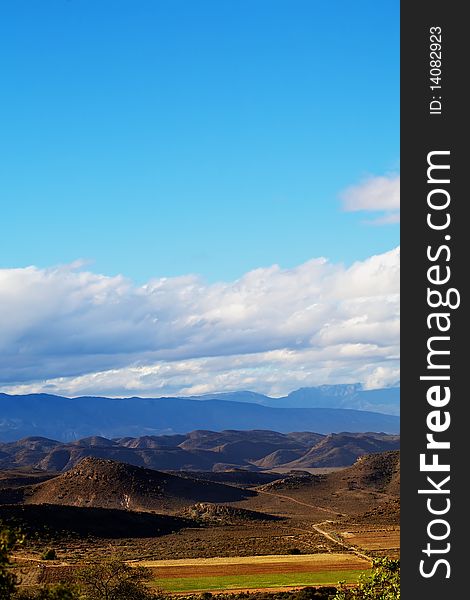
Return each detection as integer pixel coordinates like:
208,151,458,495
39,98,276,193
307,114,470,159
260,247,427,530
151,569,367,592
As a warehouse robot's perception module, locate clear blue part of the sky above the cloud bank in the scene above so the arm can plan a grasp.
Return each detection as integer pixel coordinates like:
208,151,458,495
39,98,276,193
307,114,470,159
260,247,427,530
0,0,399,283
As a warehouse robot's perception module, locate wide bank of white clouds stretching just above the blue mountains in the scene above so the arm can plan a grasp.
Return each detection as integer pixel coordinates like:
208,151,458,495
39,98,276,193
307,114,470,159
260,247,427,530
0,249,399,396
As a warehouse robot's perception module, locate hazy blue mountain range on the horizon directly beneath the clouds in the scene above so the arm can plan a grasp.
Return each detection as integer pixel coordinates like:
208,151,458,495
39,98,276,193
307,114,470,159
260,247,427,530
0,385,399,441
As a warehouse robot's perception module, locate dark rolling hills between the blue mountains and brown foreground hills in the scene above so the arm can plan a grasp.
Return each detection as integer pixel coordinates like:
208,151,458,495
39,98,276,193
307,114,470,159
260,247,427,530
0,430,400,474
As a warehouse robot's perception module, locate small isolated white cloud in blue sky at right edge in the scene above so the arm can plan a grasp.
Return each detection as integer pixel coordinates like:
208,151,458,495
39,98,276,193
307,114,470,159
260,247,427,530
341,175,400,225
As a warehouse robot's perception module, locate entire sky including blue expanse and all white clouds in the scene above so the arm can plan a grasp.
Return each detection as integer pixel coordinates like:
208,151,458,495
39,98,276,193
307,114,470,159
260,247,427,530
0,0,399,396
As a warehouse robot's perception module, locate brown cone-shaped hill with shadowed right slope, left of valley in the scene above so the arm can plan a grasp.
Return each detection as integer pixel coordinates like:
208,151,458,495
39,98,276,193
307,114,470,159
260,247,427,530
19,457,254,512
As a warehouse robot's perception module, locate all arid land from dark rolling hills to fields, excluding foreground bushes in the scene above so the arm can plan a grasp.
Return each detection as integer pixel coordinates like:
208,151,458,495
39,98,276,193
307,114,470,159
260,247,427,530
0,431,400,593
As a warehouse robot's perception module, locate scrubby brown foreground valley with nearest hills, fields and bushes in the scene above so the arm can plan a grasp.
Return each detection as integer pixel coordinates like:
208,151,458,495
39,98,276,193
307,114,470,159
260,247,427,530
0,442,399,600
